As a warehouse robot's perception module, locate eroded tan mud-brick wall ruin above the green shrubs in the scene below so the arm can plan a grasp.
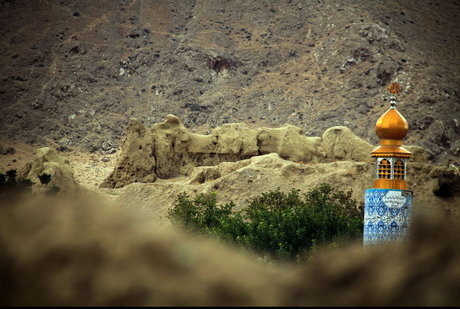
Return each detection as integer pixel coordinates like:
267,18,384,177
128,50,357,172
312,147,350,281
103,115,426,188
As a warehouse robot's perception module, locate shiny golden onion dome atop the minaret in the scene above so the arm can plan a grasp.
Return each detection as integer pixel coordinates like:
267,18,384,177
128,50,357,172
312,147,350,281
375,98,409,140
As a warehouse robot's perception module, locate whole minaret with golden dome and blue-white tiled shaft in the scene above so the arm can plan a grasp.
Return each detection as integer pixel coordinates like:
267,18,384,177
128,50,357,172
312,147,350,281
364,83,412,246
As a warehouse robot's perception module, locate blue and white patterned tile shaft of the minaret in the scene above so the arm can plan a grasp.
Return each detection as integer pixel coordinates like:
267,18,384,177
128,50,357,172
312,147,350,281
364,189,412,246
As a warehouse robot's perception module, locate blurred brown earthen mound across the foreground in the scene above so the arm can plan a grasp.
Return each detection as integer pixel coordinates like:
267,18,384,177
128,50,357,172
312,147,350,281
0,194,460,306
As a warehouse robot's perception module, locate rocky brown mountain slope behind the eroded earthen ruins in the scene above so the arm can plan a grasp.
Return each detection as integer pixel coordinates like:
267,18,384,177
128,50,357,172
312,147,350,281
0,0,460,164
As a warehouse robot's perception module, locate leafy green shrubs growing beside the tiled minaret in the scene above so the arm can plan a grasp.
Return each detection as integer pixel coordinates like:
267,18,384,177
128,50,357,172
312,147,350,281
169,184,363,259
